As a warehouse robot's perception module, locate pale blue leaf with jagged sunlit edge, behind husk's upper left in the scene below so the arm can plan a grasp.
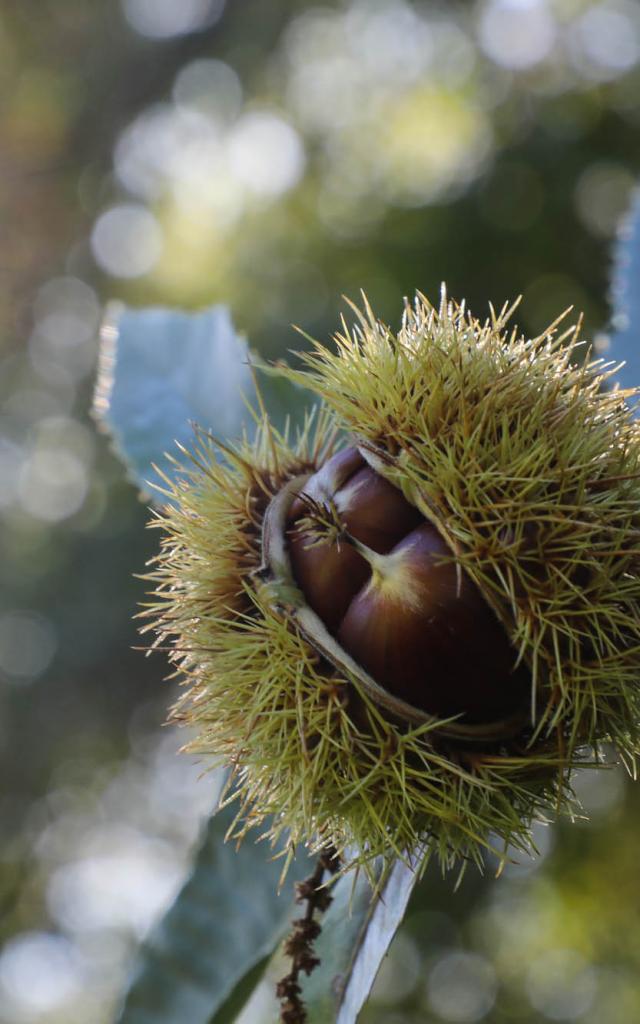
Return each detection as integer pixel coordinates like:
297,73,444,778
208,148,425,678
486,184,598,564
94,306,310,495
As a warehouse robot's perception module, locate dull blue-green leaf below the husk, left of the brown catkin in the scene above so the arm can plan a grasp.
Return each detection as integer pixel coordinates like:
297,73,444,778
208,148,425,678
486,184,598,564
117,808,311,1024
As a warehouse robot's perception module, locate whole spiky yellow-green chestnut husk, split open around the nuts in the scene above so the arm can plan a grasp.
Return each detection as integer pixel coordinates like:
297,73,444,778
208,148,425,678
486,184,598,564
146,290,640,880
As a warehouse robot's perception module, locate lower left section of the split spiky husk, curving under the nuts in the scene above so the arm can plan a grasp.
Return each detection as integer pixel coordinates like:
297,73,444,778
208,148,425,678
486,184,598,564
145,436,566,866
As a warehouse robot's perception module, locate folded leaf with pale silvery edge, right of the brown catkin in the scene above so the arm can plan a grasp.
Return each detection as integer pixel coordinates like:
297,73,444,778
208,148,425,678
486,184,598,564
302,861,418,1024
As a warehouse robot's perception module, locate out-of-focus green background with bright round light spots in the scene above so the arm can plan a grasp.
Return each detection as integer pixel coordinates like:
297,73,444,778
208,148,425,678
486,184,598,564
0,0,640,1024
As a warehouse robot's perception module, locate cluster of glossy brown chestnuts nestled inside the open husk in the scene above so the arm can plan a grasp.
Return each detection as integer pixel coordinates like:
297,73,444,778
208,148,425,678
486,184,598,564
287,446,530,725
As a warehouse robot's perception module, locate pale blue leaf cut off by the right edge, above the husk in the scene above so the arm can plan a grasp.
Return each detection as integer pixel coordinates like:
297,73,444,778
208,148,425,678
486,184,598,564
607,193,640,399
